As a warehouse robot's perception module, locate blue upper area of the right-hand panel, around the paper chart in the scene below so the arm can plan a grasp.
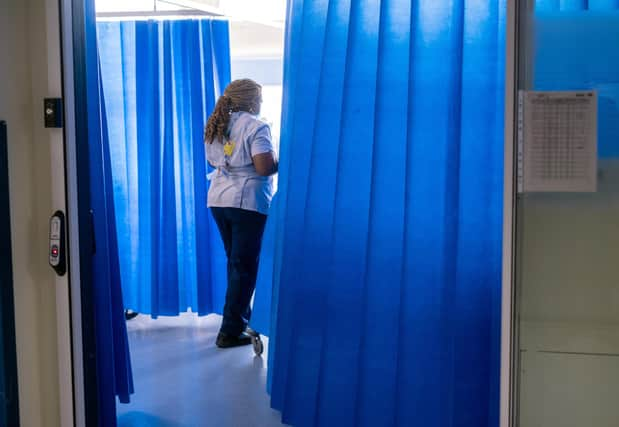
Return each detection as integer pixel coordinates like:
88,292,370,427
534,10,619,158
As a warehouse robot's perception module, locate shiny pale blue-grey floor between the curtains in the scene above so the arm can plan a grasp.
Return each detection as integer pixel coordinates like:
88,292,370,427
117,314,285,427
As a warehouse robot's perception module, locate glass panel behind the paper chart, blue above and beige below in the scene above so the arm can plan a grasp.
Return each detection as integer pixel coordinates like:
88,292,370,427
516,0,619,427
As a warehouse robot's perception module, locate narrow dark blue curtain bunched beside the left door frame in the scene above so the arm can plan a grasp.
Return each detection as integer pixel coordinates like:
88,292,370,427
81,2,133,426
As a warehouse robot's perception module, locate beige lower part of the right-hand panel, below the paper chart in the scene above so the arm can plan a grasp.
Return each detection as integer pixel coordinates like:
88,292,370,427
518,160,619,427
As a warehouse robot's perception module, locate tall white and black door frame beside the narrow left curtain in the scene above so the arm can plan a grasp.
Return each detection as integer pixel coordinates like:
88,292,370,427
60,0,99,427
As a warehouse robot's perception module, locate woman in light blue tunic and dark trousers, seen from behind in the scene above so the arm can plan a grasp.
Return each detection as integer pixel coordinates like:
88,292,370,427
204,79,278,348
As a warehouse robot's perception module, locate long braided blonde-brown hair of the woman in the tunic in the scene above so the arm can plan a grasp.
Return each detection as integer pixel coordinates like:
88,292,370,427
204,79,262,144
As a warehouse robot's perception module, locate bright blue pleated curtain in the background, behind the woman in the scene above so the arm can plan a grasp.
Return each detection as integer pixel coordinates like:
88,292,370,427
97,19,230,317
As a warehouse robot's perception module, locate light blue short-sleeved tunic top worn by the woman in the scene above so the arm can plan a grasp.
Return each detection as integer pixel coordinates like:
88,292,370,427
206,111,274,215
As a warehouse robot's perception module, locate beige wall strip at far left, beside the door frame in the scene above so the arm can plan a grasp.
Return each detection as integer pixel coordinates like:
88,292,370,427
0,0,62,427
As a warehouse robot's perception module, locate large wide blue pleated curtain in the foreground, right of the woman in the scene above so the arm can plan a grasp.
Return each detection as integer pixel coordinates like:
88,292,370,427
256,0,506,427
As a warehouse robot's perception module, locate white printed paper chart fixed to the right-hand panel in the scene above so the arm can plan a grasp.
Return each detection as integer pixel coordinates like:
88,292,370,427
518,91,597,192
